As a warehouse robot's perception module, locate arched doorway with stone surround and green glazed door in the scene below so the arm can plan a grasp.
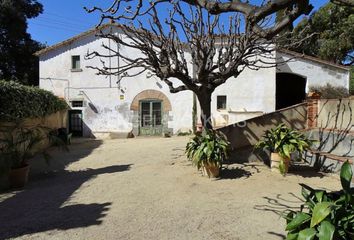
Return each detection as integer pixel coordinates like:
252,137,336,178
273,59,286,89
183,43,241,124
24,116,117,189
130,89,172,136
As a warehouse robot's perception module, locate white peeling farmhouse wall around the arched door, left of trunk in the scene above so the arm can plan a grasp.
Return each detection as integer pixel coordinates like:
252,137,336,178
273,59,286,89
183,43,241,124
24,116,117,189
40,27,193,137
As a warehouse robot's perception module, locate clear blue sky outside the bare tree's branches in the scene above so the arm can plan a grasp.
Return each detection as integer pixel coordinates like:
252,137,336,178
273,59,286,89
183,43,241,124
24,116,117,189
28,0,328,45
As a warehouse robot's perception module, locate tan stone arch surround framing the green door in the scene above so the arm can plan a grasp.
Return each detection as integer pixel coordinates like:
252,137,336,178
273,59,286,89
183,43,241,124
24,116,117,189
130,89,173,136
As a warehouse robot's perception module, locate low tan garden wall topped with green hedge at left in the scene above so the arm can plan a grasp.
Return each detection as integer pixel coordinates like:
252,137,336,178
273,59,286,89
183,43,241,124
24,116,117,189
0,80,68,152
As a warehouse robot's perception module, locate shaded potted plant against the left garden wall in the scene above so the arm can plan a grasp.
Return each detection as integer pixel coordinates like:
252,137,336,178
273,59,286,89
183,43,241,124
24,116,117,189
0,126,65,188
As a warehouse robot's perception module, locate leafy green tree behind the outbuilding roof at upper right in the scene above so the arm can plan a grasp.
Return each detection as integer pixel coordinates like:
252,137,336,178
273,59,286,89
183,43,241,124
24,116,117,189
292,3,354,65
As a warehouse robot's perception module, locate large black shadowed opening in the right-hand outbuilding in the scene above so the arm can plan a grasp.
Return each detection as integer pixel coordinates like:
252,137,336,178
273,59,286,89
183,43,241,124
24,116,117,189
276,73,306,110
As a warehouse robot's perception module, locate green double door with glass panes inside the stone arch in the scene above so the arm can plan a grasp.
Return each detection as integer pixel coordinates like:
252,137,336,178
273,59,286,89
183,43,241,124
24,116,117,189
139,100,162,136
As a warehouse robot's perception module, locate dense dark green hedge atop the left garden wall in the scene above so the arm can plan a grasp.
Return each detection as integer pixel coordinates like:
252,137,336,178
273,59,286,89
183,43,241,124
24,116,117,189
0,80,68,121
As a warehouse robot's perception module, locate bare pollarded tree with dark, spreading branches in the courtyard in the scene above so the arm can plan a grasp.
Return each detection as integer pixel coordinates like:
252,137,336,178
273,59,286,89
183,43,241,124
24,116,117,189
87,0,312,129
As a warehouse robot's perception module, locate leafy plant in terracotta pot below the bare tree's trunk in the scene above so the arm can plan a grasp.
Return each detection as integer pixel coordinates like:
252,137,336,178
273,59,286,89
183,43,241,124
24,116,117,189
186,130,230,178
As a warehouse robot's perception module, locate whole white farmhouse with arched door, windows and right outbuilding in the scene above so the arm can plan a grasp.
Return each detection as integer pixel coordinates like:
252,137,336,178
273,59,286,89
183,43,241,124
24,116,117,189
37,25,349,138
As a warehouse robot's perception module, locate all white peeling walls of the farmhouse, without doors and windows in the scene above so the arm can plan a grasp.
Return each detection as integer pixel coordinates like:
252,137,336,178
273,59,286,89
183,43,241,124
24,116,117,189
40,28,349,137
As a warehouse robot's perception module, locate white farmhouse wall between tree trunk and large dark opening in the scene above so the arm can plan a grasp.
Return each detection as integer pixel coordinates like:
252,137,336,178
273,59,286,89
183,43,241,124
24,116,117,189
211,64,275,126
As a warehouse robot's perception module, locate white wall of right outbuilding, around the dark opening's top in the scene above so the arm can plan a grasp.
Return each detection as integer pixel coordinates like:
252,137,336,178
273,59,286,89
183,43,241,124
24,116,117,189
277,52,350,92
